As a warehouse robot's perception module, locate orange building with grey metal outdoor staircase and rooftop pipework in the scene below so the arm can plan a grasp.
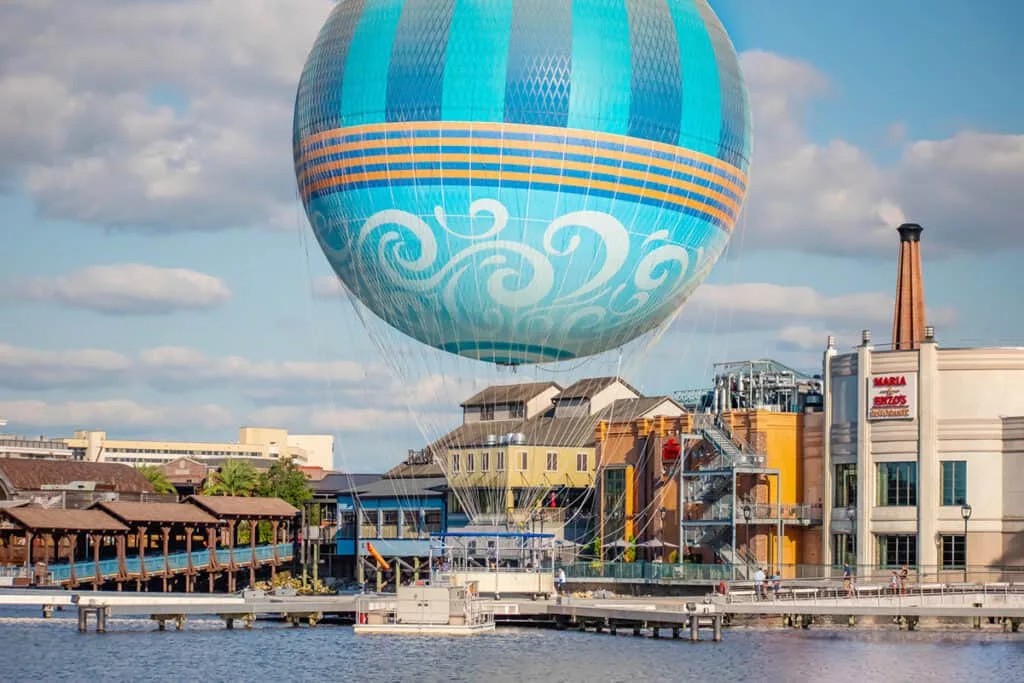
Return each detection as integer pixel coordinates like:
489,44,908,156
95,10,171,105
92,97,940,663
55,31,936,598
597,359,821,578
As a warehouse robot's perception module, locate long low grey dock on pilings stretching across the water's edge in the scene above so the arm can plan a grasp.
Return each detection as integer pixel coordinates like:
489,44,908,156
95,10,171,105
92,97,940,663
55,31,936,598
0,584,1024,641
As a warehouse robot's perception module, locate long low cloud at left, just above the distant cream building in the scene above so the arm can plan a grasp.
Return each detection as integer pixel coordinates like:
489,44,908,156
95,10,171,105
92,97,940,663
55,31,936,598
0,398,238,432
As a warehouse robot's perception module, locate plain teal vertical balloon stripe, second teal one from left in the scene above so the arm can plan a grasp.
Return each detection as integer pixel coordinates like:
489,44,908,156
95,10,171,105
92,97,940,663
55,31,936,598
441,0,513,123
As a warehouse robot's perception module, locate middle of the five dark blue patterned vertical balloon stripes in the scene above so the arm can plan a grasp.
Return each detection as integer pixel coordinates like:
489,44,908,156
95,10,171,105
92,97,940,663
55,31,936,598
505,0,572,127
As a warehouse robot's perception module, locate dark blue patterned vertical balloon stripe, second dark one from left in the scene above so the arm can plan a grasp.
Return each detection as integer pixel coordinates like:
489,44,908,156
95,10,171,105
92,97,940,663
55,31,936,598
384,0,455,122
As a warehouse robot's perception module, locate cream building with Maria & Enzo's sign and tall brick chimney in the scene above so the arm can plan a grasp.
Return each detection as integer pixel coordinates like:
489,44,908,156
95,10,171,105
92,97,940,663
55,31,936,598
816,224,1024,577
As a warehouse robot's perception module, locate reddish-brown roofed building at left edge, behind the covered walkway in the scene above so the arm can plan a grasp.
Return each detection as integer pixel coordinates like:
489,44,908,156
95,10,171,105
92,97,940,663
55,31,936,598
0,458,158,508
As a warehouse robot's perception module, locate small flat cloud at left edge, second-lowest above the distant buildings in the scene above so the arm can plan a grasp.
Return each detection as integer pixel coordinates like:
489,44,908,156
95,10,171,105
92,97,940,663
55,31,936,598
0,343,132,390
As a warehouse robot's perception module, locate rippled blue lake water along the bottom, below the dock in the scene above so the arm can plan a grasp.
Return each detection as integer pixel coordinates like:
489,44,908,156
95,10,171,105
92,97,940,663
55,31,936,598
0,609,1024,683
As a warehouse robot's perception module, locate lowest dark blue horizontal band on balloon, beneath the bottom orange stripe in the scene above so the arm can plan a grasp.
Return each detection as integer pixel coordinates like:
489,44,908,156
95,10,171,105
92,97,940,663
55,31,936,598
306,178,729,231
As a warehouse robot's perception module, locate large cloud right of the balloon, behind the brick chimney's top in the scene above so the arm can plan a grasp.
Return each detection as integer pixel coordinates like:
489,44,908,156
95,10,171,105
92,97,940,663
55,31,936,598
741,51,1024,255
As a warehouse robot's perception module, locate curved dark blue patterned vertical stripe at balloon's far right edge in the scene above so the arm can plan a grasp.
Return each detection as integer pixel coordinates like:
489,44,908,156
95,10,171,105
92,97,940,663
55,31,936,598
696,0,751,173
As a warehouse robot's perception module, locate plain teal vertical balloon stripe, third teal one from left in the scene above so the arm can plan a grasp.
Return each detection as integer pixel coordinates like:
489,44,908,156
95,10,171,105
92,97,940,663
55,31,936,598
567,0,633,135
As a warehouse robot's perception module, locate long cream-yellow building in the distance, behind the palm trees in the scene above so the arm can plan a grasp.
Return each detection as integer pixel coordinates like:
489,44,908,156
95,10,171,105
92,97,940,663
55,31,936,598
65,427,334,469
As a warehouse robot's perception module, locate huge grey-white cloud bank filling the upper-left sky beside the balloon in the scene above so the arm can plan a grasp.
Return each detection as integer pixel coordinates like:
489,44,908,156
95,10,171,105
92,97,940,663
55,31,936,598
0,0,331,230
